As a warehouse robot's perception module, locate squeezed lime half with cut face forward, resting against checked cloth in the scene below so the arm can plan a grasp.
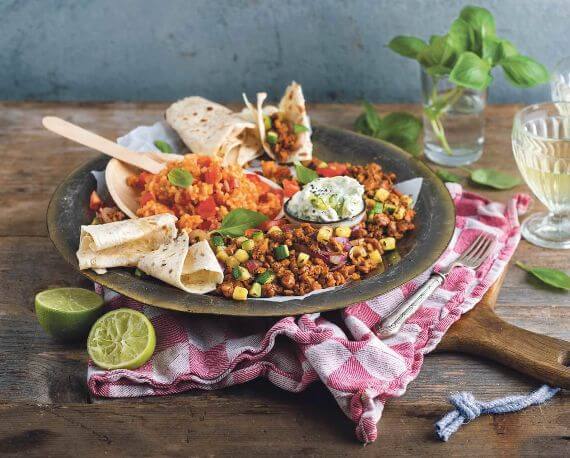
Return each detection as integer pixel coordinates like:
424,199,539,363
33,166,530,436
87,309,156,369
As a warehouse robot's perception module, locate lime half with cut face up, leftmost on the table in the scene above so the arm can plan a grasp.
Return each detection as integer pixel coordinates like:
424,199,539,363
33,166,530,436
35,288,103,340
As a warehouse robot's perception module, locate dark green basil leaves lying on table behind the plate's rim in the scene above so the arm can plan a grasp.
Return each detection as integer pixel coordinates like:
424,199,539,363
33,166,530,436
354,102,422,156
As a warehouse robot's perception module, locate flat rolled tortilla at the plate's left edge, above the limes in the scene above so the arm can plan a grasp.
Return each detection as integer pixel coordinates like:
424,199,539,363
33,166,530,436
77,213,177,270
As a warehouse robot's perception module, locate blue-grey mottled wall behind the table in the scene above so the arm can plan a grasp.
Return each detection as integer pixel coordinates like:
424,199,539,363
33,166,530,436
0,0,570,103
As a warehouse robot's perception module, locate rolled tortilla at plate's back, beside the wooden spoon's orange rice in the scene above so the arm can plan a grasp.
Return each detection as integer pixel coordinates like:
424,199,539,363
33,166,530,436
166,96,263,166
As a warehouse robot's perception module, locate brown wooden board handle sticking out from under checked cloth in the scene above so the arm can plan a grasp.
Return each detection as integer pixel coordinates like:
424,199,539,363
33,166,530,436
436,272,570,389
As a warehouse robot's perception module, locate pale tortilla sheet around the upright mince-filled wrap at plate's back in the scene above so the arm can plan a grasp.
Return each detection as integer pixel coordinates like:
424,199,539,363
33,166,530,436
243,81,313,163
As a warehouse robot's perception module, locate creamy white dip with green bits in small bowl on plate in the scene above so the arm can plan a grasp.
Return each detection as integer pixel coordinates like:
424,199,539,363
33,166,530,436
287,176,364,223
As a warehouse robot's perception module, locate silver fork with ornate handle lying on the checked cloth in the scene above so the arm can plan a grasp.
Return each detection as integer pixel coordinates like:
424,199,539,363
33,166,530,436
377,234,495,337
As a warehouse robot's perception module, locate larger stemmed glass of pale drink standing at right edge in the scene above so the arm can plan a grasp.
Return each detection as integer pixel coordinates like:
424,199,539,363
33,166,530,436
512,102,570,249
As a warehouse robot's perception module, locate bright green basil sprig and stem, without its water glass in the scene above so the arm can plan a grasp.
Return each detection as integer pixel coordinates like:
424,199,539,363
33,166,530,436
386,6,549,154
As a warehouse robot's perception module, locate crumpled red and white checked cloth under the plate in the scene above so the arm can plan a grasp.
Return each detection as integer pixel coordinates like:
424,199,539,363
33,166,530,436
87,184,530,442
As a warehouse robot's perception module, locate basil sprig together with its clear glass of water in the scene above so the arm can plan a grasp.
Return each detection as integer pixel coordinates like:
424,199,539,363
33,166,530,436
388,6,549,166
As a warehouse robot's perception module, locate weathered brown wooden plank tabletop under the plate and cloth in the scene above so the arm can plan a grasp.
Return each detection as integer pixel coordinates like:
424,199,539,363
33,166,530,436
0,102,570,456
